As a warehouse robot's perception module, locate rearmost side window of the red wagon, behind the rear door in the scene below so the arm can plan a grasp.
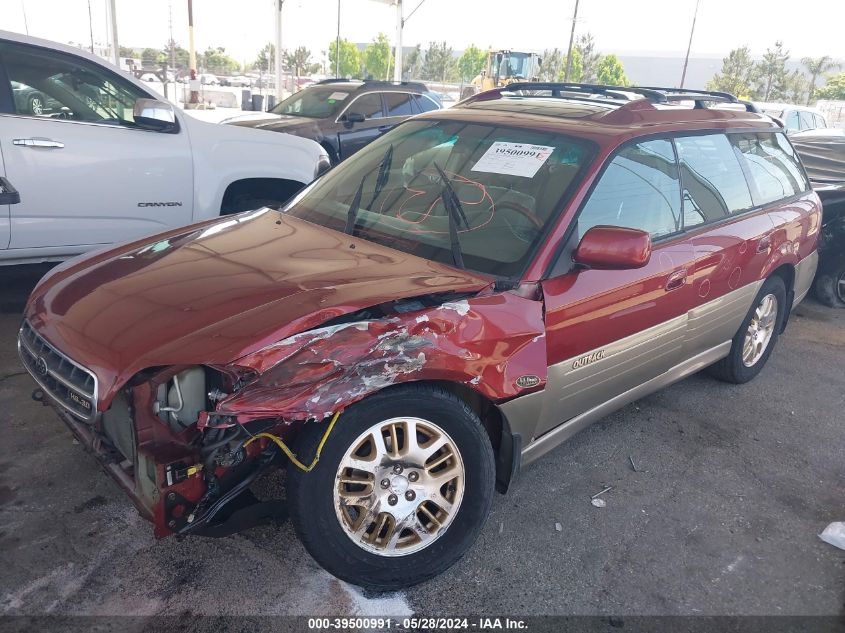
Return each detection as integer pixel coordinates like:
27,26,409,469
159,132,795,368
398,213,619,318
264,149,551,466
731,134,808,205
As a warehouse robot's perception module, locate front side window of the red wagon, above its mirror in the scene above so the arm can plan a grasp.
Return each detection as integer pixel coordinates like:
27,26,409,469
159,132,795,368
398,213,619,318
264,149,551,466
578,140,681,239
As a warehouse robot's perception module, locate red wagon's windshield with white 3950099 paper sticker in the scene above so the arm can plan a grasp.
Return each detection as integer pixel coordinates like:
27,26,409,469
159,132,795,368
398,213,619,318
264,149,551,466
284,120,590,278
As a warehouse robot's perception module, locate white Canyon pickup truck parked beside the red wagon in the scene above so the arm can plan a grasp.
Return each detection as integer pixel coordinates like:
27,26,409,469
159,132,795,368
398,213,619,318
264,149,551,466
0,31,329,264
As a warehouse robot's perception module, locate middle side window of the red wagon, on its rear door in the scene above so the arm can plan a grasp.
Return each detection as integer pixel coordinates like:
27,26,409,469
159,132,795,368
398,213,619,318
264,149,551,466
675,134,753,228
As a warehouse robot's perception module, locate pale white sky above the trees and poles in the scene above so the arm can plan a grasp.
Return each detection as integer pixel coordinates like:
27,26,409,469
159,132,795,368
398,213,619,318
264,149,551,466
6,0,845,61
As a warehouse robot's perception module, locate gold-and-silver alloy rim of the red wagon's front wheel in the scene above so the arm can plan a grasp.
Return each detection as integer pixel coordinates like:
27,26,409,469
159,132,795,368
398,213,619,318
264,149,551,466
334,417,464,556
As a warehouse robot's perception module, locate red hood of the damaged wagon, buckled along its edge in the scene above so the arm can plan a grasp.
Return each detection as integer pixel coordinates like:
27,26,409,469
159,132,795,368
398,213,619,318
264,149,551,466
25,209,492,402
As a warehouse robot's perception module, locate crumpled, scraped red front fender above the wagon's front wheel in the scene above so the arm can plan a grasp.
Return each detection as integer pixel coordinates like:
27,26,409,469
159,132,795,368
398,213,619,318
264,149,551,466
217,292,547,430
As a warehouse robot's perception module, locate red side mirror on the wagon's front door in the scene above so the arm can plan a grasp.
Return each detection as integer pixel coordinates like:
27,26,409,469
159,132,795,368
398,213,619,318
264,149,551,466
572,226,651,270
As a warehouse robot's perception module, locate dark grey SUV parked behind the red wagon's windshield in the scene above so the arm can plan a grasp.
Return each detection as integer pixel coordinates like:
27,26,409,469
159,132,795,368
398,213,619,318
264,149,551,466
223,79,441,164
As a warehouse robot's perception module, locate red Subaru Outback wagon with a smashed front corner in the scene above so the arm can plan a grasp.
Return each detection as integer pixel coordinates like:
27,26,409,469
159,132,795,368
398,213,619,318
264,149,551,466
19,84,821,589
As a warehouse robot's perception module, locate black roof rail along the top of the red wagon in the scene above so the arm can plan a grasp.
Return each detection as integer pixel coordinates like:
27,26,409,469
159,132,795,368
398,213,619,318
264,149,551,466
497,81,758,112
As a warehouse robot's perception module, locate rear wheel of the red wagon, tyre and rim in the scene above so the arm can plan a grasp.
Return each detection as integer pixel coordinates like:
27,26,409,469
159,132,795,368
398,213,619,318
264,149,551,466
710,276,788,384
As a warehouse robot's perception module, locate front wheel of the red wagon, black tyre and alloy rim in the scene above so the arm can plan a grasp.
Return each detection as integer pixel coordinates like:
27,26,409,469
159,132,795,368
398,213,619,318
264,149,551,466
287,385,495,591
